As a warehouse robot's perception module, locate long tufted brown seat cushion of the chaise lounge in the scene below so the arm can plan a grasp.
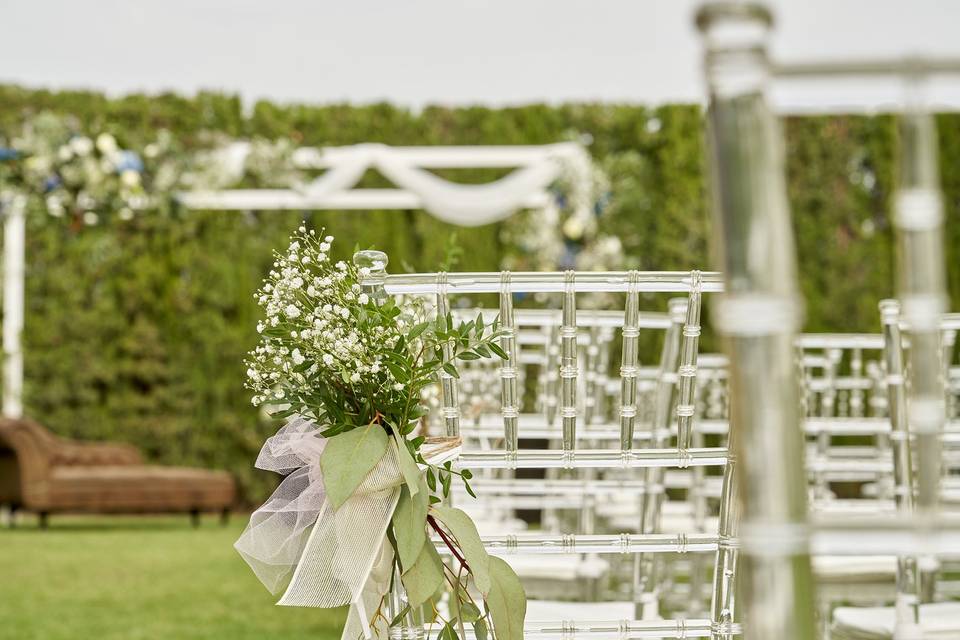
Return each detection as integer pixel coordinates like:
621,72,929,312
41,465,236,513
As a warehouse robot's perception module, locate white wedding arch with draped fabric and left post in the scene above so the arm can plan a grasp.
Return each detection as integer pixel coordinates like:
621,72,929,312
0,142,592,418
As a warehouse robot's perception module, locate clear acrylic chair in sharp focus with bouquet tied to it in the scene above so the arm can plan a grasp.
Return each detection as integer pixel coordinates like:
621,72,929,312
357,253,739,638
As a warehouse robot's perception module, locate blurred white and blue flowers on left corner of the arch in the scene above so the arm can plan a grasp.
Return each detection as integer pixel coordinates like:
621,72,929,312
0,112,302,229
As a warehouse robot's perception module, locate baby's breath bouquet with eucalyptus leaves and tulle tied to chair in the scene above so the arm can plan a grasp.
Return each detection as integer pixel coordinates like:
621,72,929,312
235,226,526,640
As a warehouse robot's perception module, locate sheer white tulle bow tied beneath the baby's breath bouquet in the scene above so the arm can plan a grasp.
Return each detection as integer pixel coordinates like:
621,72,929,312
234,416,459,640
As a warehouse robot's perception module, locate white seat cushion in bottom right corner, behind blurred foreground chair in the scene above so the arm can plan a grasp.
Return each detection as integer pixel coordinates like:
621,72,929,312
831,602,960,640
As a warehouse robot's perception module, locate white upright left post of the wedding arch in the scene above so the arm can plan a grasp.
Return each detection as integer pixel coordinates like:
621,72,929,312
0,192,27,418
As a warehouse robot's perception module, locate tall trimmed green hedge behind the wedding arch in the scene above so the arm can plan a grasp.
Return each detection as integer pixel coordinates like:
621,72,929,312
0,86,960,497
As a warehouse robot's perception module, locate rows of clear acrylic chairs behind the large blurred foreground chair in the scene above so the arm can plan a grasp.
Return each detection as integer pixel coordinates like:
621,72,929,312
356,248,960,637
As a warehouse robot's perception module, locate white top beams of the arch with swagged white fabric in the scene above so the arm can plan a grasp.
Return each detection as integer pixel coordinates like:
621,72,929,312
181,142,592,226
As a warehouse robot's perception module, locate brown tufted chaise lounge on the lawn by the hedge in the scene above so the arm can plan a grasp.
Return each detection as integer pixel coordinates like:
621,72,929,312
0,418,236,526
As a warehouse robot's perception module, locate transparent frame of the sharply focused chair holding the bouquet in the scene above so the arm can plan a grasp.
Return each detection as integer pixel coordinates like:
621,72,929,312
356,254,739,638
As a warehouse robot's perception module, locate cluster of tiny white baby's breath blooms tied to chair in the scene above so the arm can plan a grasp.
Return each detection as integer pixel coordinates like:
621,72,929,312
247,226,410,406
